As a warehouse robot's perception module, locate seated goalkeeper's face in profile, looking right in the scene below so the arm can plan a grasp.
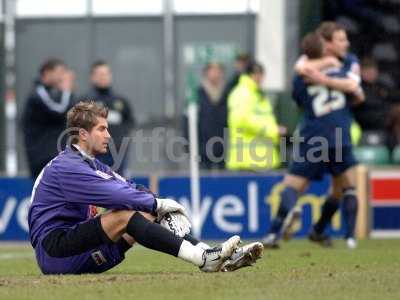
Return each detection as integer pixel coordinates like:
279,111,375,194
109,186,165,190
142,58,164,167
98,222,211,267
88,118,111,156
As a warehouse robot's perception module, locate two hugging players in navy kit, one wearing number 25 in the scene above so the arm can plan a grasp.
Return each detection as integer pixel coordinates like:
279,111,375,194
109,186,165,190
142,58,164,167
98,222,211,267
264,22,364,248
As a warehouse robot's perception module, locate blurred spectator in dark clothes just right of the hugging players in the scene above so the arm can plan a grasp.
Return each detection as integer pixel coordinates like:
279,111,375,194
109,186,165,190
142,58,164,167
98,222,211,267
353,58,389,131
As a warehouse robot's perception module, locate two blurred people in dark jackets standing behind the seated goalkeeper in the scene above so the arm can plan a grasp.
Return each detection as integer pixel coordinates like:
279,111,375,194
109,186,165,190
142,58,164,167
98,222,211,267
22,58,135,178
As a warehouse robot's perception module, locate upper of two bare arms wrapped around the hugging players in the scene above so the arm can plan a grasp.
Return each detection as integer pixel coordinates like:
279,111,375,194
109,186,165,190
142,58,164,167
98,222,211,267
294,55,341,76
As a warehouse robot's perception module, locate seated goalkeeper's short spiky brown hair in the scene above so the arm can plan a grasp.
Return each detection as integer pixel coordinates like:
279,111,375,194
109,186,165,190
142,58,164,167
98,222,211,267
67,100,108,143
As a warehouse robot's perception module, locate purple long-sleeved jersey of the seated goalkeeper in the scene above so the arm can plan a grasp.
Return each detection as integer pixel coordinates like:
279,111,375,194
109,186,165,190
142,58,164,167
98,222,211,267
28,146,156,247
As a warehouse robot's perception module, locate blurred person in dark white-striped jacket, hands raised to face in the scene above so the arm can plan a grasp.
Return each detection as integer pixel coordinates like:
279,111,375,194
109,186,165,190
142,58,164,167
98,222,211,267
22,59,75,178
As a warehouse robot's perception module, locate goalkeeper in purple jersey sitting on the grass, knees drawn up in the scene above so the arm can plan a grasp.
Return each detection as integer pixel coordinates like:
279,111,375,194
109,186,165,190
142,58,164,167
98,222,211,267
28,102,262,274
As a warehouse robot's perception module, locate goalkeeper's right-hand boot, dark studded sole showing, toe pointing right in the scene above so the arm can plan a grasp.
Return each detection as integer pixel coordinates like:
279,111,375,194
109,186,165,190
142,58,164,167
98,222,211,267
221,242,264,272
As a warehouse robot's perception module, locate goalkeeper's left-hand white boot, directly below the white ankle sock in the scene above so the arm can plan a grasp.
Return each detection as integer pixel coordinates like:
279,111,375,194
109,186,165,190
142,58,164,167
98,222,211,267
200,235,240,272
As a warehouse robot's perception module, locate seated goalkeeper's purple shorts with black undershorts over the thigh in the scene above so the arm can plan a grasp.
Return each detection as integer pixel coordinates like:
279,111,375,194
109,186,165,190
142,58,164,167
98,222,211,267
35,218,130,274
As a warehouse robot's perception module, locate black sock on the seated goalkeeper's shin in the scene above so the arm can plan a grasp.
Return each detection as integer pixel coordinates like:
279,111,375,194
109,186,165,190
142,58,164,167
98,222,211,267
126,213,183,256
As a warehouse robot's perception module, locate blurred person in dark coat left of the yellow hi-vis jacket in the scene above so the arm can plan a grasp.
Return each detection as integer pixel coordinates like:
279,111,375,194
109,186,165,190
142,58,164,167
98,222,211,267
197,63,226,169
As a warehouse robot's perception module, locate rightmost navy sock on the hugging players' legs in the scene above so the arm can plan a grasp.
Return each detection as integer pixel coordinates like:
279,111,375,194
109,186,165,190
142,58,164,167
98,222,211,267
343,188,358,239
